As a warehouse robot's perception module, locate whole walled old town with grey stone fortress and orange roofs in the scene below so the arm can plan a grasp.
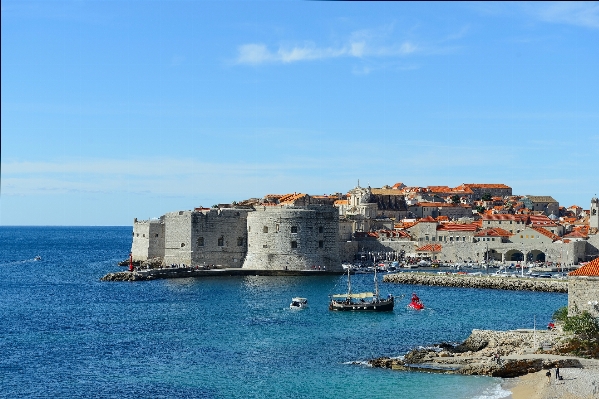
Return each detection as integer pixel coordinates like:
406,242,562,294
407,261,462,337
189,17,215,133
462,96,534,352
131,183,599,271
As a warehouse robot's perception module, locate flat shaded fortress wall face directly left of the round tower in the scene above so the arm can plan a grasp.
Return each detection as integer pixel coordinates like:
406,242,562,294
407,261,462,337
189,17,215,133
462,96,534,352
191,208,252,268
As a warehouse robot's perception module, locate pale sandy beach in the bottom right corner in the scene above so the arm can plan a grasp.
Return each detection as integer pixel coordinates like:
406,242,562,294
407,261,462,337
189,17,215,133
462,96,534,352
503,367,599,399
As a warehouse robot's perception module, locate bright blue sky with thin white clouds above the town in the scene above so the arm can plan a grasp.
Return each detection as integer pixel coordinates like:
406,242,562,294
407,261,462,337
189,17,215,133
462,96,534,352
0,0,599,225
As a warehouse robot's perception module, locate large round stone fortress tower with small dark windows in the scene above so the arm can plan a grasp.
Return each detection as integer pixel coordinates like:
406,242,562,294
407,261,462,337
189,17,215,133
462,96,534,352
243,205,342,271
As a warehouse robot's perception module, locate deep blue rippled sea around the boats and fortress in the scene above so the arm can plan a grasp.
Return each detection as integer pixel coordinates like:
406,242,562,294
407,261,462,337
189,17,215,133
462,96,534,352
0,226,567,399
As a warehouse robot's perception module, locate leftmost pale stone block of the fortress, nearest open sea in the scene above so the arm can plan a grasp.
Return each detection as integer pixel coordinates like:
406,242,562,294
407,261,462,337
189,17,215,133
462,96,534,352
131,219,164,261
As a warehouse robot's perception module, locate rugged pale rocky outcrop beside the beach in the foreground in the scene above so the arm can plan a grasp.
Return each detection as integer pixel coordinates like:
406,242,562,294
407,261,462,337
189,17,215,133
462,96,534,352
368,330,599,377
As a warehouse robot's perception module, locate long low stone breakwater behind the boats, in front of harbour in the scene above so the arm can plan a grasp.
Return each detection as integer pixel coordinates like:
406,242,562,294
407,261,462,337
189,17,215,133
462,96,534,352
383,272,568,292
